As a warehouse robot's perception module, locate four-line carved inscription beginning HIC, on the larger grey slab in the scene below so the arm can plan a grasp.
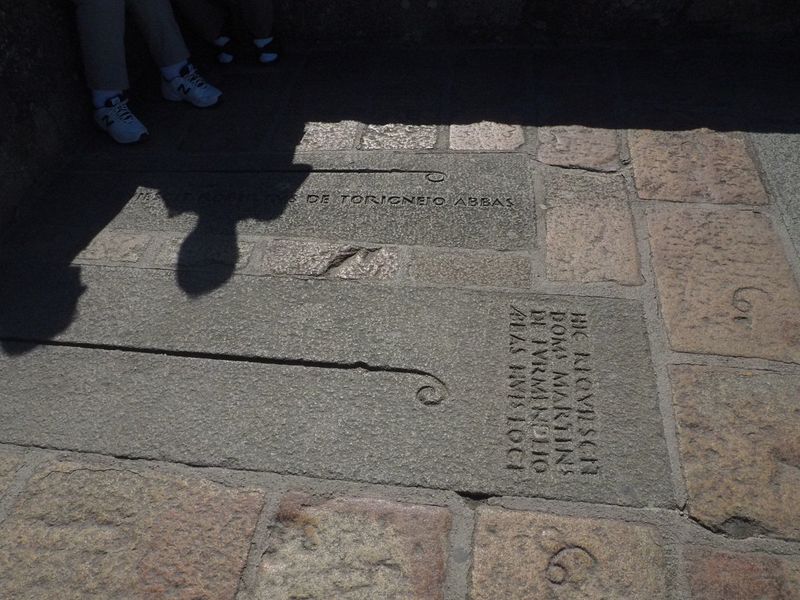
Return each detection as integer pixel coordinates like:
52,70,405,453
505,304,601,477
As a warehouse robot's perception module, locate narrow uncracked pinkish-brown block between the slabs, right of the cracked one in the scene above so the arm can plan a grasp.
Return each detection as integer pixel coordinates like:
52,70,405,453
408,248,531,289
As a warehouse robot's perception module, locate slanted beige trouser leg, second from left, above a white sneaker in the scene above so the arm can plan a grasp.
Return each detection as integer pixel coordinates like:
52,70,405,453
127,0,189,70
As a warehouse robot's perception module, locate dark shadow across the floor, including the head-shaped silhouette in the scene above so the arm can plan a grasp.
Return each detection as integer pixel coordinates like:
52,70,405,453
0,46,800,352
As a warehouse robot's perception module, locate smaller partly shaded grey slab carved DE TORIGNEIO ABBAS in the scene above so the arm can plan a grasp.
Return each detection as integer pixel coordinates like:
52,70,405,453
40,152,536,250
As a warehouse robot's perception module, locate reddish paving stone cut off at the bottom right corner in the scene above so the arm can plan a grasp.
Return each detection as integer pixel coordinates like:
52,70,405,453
685,547,800,600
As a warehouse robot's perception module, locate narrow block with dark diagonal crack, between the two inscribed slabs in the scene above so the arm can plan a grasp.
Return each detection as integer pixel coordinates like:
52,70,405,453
252,240,402,279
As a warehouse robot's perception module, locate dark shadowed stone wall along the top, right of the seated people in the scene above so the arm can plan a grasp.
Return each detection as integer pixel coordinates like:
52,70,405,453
268,0,800,48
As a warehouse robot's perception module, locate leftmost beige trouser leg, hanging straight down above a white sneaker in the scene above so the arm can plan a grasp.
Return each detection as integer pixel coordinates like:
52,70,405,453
75,0,128,91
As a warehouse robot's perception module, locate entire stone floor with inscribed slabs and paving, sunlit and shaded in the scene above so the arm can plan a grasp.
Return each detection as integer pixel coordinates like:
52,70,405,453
0,48,800,600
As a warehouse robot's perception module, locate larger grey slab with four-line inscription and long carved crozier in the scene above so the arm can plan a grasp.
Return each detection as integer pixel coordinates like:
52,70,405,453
0,267,673,506
